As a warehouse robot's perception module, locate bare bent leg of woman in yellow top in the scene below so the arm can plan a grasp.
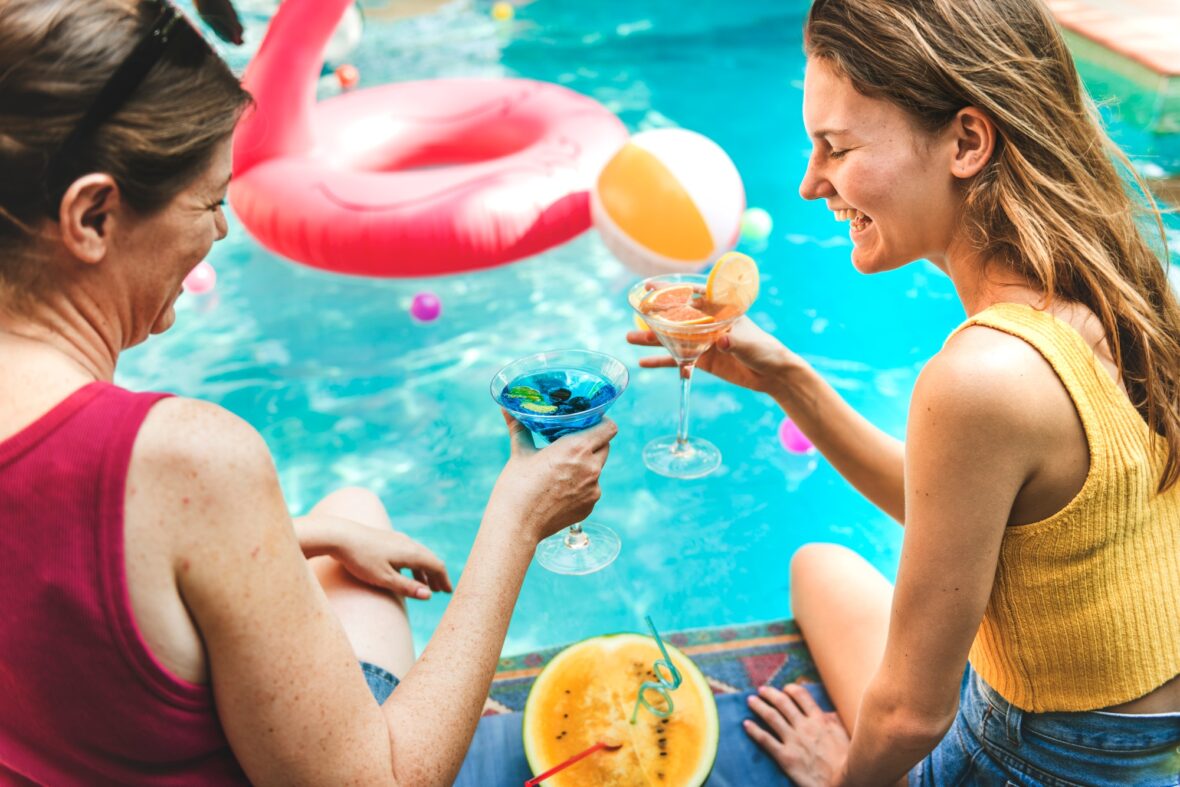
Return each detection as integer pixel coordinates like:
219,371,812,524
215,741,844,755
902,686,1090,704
791,544,893,734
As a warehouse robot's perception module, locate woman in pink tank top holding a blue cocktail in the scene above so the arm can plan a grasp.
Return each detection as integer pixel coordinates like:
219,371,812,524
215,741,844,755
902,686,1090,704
0,0,615,786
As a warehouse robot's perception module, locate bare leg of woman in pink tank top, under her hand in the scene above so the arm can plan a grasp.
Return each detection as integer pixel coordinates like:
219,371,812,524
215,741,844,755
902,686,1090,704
309,488,414,677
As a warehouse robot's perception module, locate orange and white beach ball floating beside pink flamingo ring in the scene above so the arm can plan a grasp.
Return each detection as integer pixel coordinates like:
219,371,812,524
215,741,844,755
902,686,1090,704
590,129,746,276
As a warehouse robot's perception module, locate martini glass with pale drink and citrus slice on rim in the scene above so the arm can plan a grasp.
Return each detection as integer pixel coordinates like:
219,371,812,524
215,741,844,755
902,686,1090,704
627,274,745,478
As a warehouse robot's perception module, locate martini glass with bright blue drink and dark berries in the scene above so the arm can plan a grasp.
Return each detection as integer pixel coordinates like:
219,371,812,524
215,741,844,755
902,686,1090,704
491,349,628,575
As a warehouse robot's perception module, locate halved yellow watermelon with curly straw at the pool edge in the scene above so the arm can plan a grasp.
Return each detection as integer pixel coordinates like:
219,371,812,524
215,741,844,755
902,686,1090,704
524,634,720,787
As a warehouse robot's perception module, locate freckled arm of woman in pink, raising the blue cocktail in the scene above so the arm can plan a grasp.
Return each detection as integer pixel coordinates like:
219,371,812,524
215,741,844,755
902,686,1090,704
148,401,615,787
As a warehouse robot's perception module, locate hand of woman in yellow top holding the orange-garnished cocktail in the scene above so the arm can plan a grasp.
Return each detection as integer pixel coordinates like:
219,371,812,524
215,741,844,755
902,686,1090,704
627,317,807,394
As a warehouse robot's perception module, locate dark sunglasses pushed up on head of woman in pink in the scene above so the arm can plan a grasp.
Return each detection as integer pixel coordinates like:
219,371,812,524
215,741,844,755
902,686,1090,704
45,0,212,218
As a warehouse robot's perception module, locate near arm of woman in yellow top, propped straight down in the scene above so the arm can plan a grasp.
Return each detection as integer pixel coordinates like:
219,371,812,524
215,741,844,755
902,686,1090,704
840,336,1041,785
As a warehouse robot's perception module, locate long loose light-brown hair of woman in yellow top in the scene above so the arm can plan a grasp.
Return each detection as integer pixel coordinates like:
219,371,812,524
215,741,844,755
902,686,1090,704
805,0,1180,491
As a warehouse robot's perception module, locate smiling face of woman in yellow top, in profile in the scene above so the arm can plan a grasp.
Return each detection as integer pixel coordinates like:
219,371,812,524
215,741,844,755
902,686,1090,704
799,58,962,274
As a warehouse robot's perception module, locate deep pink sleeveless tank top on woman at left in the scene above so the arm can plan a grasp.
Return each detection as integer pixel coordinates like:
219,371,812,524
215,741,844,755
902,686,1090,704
0,382,247,785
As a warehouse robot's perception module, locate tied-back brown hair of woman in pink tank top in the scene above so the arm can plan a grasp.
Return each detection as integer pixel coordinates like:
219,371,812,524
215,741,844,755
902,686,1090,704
0,0,250,283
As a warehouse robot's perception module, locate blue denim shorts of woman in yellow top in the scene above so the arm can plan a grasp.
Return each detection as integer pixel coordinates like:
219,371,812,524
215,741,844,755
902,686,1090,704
910,668,1180,787
